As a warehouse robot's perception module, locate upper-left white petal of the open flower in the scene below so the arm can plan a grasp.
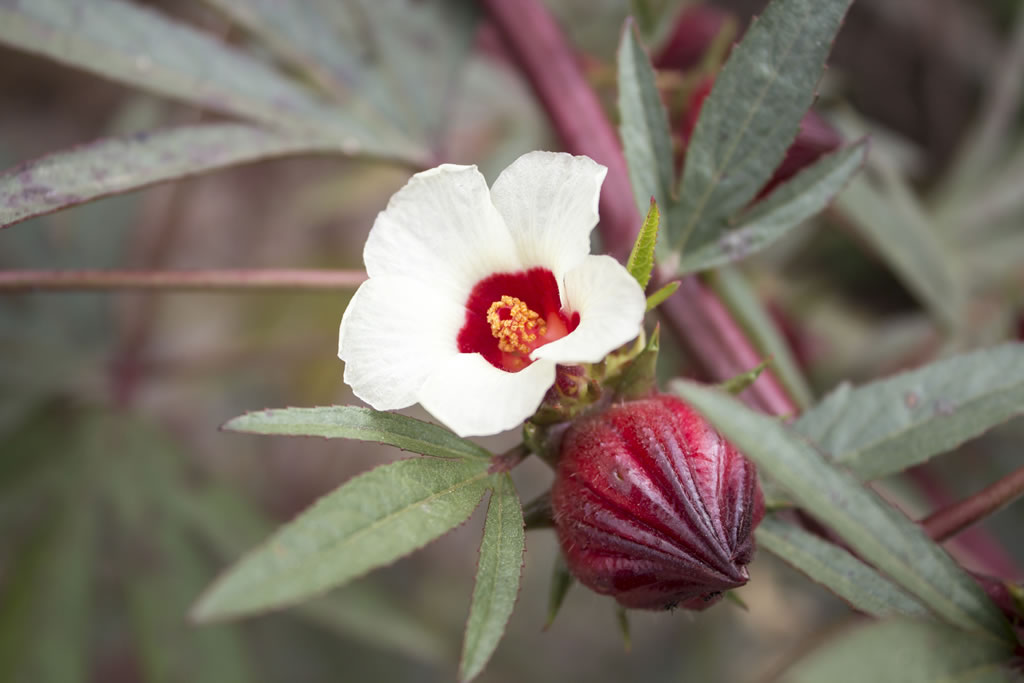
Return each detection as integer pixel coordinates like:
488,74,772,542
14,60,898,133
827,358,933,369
362,164,522,305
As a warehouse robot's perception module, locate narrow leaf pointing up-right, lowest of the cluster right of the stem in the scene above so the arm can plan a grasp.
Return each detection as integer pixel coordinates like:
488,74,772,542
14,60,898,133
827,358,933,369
677,141,867,273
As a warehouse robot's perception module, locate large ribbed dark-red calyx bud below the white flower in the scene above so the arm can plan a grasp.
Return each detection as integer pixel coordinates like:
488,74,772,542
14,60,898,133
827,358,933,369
551,395,764,609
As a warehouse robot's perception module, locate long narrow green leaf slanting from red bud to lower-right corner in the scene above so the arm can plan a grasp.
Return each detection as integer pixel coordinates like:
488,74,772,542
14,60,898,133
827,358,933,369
672,380,1013,639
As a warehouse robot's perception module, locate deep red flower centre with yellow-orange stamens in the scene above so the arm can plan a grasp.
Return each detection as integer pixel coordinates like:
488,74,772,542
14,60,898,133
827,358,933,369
458,268,580,373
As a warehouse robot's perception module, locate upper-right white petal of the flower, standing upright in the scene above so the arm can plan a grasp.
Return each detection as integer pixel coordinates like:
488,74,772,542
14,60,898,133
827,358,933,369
490,152,608,281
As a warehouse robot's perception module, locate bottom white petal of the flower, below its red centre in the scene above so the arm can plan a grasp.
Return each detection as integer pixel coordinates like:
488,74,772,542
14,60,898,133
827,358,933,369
420,353,555,436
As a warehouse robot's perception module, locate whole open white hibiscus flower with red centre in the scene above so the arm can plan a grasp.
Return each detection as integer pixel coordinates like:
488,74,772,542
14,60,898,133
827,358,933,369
338,152,645,436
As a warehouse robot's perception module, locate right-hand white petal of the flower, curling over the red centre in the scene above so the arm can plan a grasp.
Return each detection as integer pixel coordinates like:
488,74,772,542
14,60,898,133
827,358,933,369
530,256,647,364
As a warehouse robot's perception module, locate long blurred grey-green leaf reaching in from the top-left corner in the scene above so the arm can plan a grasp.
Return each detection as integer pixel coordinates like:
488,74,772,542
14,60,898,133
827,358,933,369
0,0,425,161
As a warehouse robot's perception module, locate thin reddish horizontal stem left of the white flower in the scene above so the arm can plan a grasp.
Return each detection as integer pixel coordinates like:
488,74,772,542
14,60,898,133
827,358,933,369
0,268,367,293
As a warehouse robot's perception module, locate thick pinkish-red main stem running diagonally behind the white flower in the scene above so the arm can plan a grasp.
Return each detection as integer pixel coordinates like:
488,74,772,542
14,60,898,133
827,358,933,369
480,0,797,415
